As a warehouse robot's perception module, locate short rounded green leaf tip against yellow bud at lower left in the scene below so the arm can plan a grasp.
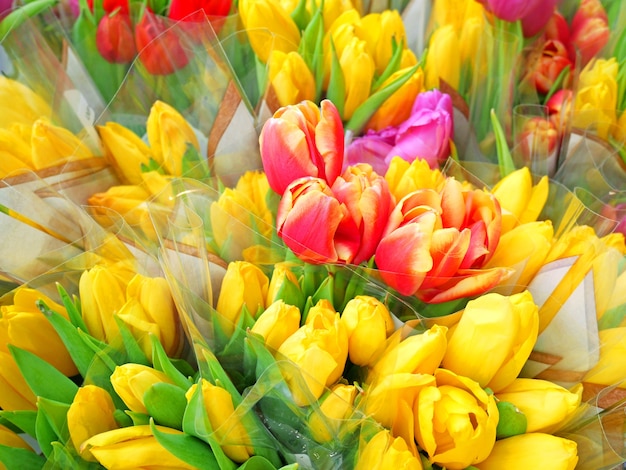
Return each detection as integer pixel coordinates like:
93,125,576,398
143,382,187,430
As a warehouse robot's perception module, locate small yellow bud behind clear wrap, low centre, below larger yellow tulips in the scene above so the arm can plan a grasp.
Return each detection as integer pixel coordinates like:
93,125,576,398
309,384,359,443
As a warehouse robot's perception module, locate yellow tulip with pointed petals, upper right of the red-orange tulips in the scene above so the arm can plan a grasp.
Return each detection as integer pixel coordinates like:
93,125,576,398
491,167,549,233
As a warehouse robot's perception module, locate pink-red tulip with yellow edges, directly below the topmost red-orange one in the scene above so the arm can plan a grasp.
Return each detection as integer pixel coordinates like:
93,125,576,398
276,176,361,264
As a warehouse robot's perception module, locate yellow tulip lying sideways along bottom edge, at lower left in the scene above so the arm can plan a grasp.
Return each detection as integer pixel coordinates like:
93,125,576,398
82,424,196,470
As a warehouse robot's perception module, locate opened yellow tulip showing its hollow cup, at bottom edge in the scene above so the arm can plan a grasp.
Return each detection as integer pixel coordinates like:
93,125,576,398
414,370,498,469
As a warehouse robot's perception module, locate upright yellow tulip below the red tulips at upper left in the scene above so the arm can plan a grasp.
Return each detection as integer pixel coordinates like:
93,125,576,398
146,101,200,176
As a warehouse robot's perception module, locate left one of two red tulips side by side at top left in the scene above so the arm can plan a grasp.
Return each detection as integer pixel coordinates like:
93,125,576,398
96,11,137,64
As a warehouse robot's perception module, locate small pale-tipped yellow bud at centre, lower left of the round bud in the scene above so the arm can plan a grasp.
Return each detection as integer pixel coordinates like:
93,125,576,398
250,300,300,352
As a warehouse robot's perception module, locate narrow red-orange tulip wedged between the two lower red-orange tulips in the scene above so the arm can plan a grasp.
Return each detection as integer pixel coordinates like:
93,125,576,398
332,163,394,264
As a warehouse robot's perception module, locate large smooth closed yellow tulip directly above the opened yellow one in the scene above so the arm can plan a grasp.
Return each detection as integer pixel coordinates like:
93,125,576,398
442,291,539,392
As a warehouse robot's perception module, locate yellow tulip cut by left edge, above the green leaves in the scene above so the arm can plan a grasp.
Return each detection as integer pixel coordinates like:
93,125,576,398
0,287,78,377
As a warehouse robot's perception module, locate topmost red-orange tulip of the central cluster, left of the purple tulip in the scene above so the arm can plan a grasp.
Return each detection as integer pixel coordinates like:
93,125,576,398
259,100,344,194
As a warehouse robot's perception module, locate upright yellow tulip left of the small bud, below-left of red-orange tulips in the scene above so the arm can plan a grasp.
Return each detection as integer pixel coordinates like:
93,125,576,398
216,261,269,337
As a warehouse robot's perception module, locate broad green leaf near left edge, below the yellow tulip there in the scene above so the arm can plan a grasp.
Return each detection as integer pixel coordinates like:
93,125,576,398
9,344,78,404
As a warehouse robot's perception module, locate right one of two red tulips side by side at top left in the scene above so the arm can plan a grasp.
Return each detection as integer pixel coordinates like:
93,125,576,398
135,10,189,75
